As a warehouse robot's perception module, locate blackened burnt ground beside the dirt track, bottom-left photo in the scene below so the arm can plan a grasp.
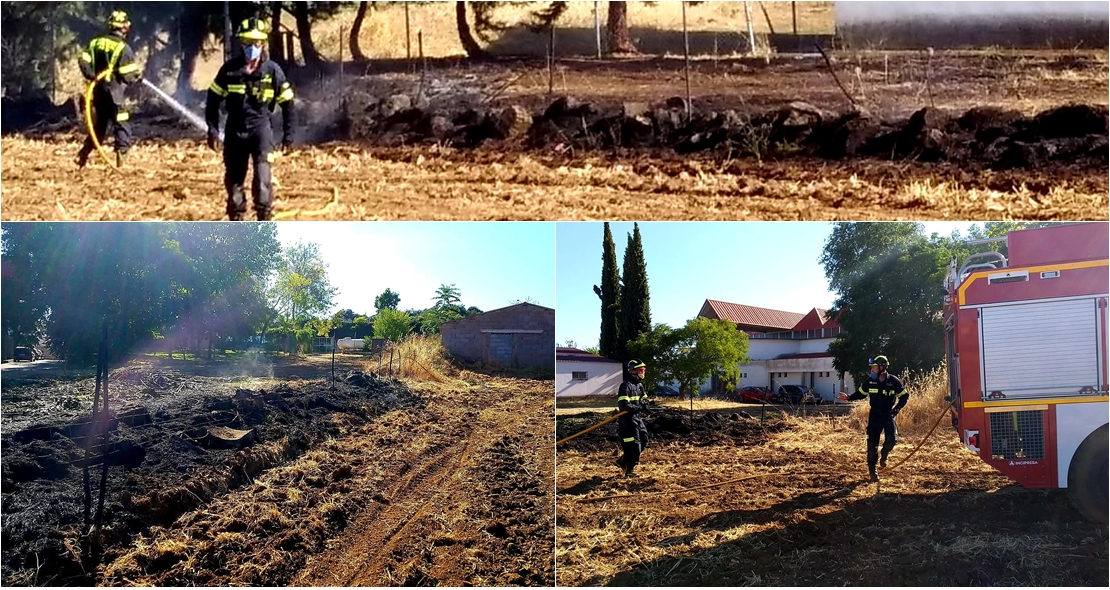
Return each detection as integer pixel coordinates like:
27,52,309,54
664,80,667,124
2,370,422,584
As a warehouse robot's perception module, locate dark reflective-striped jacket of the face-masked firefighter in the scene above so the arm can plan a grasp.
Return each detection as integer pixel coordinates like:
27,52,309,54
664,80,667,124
204,55,293,138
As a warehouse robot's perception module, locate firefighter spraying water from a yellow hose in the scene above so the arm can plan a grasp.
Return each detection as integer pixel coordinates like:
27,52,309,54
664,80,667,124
77,10,142,167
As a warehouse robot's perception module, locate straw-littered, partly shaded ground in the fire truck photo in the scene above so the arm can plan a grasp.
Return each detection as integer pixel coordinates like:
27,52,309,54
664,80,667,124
556,408,1110,587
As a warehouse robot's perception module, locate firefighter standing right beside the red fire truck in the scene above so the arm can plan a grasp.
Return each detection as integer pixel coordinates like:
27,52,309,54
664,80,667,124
846,355,909,481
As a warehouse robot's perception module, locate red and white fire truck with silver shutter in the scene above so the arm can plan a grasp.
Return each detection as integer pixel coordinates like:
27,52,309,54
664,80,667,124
944,223,1110,522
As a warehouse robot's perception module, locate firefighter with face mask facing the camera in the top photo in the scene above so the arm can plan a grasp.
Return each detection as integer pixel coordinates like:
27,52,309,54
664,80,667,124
204,18,293,221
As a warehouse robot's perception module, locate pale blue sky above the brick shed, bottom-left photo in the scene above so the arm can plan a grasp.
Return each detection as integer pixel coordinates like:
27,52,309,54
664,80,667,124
278,222,555,315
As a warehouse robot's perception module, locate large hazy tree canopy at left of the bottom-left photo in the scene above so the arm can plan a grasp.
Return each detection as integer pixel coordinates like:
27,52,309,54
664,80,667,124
0,223,278,360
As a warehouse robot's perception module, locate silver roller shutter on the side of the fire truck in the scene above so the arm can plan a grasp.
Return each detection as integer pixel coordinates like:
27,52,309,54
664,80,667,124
979,297,1101,398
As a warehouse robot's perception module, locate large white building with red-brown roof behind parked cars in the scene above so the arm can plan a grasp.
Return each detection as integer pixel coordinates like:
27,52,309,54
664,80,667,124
698,299,856,400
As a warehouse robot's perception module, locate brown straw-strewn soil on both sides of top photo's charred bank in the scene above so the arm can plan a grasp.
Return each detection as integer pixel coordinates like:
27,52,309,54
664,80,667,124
0,51,1110,221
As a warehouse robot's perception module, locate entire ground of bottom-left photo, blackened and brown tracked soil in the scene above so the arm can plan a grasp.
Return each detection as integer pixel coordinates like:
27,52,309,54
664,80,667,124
2,354,554,586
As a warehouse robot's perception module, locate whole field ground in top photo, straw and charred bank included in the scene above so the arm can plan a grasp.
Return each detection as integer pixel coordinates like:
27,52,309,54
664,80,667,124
0,2,1110,221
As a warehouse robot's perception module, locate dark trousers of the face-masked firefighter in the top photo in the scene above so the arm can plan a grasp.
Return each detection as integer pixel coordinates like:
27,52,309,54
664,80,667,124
223,125,274,221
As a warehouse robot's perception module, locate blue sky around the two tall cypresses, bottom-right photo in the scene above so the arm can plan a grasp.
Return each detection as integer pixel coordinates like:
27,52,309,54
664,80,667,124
555,222,972,348
